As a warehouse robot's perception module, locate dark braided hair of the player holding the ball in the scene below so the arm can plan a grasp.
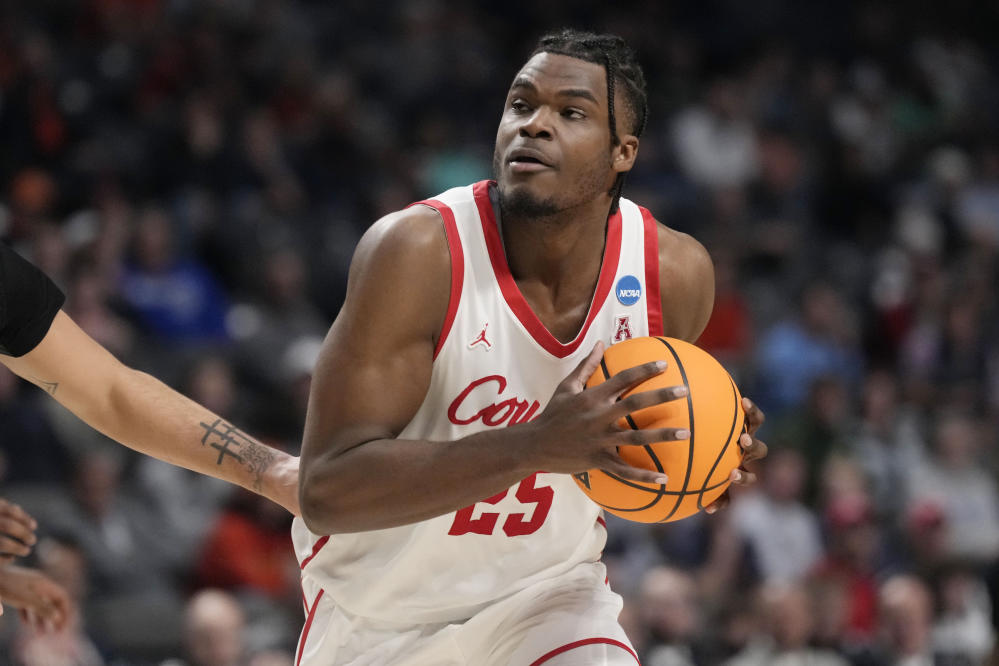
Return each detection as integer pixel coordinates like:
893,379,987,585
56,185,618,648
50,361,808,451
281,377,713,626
531,28,649,214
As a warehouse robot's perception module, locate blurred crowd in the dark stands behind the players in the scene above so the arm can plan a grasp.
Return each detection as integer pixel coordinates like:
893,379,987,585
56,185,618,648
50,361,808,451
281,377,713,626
0,0,999,666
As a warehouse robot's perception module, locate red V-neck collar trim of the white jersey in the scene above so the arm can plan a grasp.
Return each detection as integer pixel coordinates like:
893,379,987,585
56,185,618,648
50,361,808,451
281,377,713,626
473,180,621,358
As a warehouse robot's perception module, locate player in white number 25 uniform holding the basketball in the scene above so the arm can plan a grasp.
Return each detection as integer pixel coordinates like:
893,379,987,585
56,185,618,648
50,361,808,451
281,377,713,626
293,31,765,666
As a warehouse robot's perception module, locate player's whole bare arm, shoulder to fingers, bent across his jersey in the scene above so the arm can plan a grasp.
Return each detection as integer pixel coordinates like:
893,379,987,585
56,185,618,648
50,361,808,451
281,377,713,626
301,206,679,534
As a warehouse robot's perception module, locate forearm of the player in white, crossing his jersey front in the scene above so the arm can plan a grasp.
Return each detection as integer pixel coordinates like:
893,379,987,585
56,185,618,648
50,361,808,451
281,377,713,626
300,426,538,534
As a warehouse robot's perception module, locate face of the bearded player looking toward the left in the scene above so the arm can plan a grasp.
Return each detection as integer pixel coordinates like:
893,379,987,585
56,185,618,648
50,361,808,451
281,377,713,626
493,53,638,214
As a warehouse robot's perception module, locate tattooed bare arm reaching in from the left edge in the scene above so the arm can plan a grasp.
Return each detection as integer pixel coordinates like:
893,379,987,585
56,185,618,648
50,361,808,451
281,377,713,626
0,311,298,515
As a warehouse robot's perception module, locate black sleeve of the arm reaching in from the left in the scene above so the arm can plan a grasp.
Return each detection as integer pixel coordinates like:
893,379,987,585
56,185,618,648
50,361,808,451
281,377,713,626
0,243,66,356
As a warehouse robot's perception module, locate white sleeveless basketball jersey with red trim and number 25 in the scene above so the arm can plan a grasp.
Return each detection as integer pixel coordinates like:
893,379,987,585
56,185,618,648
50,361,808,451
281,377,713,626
292,181,662,624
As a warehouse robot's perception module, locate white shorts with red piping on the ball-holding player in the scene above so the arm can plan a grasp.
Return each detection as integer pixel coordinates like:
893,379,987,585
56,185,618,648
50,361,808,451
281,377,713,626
296,562,639,666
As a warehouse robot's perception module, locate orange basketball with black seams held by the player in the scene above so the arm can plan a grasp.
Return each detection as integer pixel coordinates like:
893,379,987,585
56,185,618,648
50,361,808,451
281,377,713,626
574,337,746,523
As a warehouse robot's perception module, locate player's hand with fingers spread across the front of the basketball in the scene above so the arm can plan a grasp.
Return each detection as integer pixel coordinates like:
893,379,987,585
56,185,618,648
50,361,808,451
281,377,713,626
526,342,690,484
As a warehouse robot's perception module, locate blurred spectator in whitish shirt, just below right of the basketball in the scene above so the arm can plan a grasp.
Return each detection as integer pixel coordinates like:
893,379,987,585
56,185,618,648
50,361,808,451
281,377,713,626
732,449,823,581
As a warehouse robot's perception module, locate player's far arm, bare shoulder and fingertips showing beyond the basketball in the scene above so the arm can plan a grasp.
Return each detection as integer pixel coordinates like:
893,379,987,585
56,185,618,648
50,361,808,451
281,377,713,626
659,225,767,504
